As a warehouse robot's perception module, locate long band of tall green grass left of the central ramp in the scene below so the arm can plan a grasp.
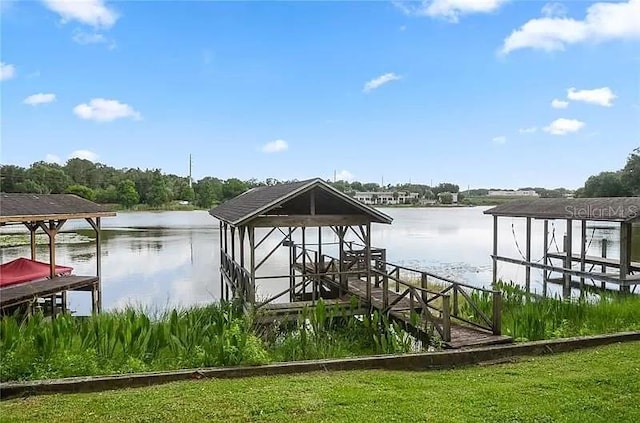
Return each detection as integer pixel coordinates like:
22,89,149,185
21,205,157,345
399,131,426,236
0,301,412,381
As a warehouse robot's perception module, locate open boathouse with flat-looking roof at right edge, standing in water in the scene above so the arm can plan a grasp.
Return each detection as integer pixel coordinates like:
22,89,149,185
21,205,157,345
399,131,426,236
484,197,640,297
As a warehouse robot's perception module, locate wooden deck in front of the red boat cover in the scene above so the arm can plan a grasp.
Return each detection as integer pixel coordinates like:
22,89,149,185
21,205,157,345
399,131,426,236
0,275,99,309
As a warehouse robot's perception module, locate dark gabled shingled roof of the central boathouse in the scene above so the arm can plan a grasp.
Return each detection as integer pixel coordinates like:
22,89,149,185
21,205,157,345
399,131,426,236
209,178,393,226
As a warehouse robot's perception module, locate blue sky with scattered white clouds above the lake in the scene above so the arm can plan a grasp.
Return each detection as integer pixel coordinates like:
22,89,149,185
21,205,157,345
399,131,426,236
0,0,640,188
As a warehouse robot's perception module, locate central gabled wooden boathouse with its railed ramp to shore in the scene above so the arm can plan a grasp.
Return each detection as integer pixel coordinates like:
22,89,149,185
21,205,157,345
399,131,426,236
210,178,511,348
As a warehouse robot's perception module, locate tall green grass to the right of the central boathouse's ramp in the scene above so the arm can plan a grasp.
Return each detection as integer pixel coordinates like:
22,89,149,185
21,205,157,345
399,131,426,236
461,282,640,341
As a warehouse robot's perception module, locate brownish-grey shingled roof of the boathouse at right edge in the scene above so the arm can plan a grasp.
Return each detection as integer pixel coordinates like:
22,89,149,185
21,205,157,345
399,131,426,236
484,197,640,222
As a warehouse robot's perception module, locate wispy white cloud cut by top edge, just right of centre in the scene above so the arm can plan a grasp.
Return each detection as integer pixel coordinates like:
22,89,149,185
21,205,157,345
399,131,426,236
393,0,509,22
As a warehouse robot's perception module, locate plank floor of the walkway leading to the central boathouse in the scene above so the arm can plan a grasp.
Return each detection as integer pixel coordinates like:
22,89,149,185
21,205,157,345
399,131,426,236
294,264,513,348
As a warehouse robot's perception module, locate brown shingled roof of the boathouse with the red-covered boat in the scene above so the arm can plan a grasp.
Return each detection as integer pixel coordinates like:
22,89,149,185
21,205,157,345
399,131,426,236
0,193,116,223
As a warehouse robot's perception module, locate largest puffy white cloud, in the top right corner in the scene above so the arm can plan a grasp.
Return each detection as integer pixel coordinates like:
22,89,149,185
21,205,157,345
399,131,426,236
500,0,640,54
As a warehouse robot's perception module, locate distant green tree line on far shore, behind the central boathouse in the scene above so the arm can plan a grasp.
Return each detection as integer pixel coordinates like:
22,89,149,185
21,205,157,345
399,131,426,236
0,158,459,208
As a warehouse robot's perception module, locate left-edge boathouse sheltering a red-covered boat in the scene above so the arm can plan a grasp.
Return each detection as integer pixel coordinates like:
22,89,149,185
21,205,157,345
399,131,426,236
0,193,116,317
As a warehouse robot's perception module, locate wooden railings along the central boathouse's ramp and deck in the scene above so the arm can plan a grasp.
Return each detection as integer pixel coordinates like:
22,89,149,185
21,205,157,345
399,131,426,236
291,243,502,341
